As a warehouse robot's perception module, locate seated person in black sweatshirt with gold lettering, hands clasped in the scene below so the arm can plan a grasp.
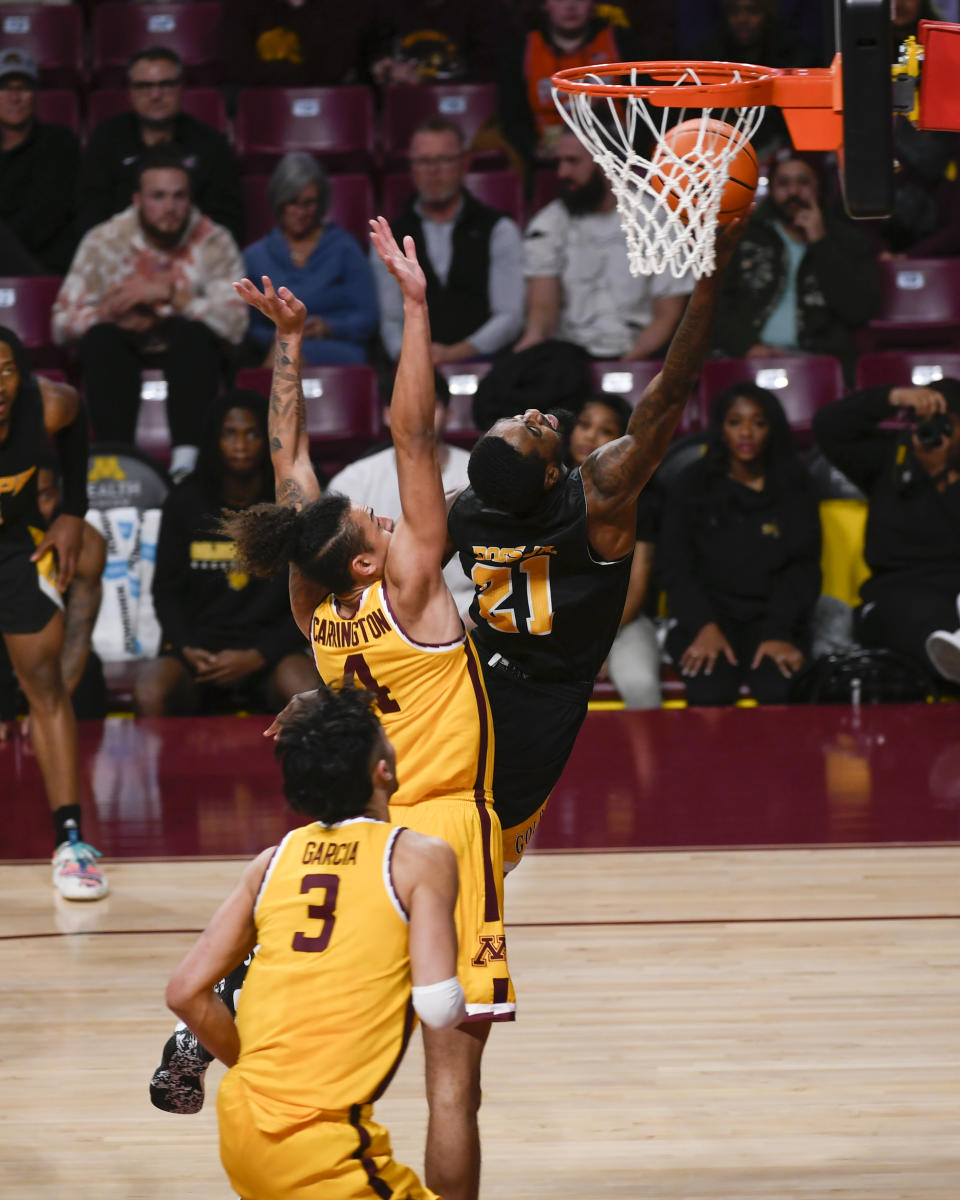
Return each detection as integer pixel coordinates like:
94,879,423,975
134,390,318,716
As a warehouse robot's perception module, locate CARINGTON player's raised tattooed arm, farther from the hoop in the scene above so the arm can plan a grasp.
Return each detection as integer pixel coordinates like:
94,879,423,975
234,275,322,509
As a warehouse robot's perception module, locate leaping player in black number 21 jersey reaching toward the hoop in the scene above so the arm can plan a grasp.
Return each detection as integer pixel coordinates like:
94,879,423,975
448,218,744,870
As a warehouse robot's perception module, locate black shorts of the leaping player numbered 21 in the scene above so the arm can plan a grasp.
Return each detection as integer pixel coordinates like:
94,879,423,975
481,655,593,829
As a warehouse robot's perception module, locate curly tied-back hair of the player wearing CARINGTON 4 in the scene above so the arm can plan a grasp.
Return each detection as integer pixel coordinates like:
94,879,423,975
220,492,370,595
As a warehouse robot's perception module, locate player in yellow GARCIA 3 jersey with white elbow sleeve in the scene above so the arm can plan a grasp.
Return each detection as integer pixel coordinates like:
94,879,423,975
167,686,464,1200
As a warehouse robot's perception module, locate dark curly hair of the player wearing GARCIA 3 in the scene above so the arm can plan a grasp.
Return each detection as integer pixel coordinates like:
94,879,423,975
274,683,384,826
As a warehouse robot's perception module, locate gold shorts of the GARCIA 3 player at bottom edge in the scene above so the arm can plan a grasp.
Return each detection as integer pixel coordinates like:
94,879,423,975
217,1070,439,1200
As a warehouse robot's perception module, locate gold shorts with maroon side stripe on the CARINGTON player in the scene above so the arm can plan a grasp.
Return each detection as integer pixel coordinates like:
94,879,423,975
390,800,517,1021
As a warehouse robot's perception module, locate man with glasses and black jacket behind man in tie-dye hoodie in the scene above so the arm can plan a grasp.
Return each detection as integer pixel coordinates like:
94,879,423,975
79,46,244,244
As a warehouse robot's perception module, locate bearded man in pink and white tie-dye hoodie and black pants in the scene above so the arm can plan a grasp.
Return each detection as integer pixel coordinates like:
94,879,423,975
53,146,247,475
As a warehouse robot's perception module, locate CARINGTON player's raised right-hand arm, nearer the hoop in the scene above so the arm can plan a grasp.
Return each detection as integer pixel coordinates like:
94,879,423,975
370,217,460,637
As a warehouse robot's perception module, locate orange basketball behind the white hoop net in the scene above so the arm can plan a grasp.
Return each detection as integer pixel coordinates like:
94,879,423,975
649,119,760,226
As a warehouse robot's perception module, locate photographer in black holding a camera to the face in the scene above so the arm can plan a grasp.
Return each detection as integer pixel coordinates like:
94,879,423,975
814,379,960,677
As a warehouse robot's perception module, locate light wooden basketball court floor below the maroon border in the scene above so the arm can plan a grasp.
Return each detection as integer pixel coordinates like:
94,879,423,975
0,846,960,1200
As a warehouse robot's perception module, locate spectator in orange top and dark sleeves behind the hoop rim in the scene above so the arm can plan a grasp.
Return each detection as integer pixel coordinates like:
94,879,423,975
499,0,643,166
